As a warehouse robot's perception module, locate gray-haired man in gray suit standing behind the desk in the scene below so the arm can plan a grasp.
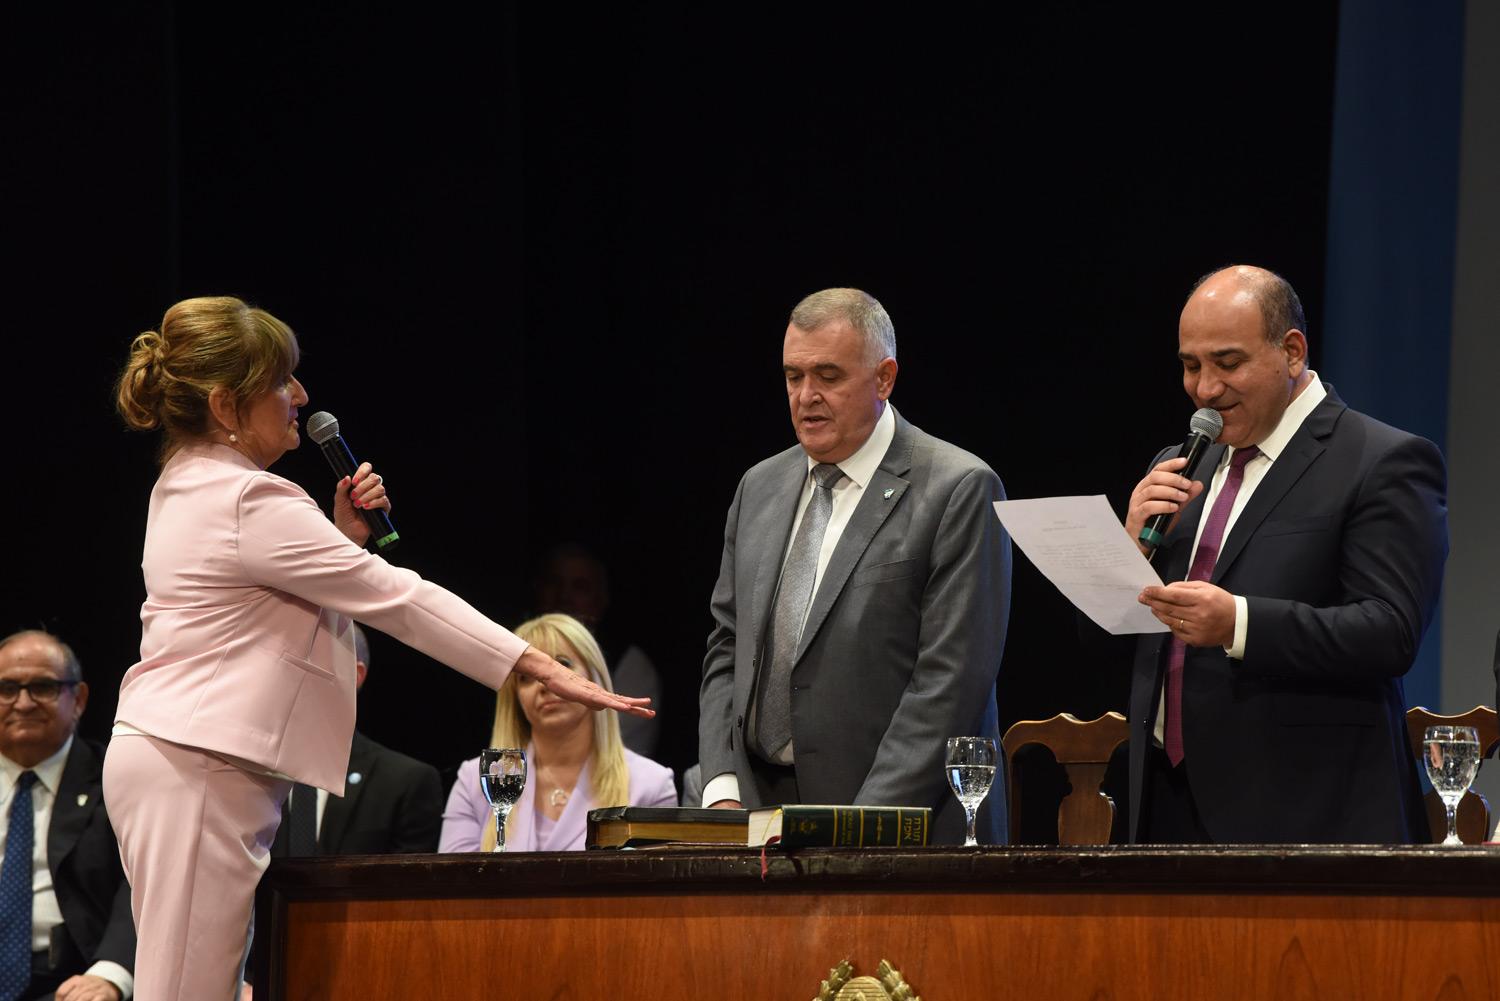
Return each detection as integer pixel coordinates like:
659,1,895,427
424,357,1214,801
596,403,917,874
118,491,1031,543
699,288,1011,843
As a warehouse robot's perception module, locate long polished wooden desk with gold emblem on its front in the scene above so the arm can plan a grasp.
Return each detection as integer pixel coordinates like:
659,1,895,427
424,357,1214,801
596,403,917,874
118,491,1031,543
255,846,1500,1001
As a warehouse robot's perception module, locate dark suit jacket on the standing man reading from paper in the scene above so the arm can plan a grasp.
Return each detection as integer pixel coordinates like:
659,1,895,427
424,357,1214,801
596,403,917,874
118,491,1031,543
1130,386,1448,843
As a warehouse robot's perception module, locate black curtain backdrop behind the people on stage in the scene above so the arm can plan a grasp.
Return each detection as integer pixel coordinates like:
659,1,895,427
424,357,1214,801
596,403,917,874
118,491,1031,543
0,3,1337,840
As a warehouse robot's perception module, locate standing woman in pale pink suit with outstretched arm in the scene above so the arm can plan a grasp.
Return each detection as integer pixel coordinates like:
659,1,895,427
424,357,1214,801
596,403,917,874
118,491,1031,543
104,297,650,1001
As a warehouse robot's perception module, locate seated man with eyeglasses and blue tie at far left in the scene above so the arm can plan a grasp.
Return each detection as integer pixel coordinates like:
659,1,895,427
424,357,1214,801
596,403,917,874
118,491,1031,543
0,630,135,1001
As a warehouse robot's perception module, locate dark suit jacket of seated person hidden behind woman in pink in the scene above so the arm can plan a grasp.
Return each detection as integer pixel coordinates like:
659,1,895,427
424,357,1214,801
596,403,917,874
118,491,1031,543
272,731,443,857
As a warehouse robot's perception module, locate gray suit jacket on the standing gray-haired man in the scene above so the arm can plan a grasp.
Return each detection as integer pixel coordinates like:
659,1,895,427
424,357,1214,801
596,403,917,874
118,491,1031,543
699,414,1011,843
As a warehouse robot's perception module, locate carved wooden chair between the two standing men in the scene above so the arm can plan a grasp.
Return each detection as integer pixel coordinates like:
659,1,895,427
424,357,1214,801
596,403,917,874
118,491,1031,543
1002,713,1130,845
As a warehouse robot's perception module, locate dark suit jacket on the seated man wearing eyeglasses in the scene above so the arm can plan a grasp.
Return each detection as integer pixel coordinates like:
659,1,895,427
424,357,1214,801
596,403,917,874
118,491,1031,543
37,737,135,980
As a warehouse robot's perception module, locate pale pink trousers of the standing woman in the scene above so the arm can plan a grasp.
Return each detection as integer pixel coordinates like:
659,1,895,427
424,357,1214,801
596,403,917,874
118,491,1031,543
104,734,291,1001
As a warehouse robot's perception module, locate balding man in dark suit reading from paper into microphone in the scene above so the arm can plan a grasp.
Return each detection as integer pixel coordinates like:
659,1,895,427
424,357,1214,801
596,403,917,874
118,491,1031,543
1125,267,1448,843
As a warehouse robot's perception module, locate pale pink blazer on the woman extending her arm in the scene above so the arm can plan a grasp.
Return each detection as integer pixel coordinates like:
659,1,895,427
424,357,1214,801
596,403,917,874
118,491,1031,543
116,444,527,795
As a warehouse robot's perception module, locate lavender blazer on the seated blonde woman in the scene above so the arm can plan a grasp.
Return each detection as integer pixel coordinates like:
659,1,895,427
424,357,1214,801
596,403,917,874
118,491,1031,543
438,746,677,851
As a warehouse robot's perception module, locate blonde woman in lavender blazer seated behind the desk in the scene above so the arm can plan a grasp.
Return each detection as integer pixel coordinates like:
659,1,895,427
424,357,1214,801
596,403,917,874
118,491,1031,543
438,615,677,851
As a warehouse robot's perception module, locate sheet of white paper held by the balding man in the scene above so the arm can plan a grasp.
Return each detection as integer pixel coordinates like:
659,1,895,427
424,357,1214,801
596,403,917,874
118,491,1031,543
995,494,1167,635
